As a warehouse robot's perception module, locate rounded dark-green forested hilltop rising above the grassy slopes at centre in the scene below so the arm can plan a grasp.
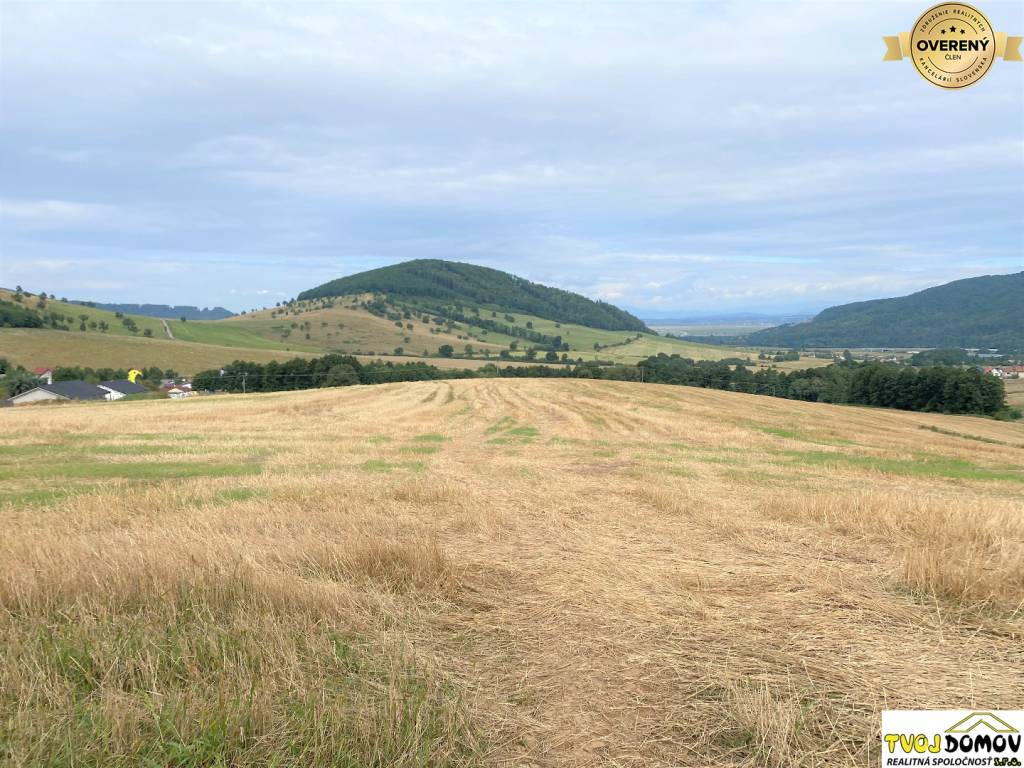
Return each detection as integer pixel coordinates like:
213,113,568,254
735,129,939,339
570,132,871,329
298,259,649,332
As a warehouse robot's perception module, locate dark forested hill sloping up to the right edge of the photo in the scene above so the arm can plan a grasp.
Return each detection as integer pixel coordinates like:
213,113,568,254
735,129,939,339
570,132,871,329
742,272,1024,349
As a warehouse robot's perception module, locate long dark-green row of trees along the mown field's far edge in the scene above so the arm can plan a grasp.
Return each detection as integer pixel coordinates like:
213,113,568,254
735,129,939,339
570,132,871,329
193,354,1019,418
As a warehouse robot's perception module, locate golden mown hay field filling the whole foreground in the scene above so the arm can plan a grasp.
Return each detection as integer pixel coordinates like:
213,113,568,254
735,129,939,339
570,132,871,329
0,379,1024,766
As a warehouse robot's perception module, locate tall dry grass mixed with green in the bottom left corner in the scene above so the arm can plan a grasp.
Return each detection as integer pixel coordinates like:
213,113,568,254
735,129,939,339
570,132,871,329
0,614,481,768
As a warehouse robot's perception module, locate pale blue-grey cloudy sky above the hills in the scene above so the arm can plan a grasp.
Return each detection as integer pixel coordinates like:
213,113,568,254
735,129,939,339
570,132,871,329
0,0,1024,316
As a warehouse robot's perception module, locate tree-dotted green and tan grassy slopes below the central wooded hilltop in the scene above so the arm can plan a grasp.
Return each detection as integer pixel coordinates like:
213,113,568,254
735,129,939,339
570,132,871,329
0,289,737,374
